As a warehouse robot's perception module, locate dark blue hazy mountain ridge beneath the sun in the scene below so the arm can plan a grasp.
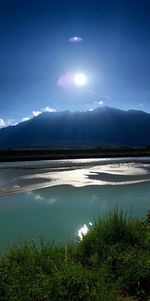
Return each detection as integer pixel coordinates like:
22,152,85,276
0,107,150,148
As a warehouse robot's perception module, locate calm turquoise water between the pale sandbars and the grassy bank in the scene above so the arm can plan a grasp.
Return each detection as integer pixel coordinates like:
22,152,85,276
0,158,150,251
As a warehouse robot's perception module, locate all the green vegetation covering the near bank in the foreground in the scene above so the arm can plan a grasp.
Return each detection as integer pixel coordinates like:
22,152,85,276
0,210,150,301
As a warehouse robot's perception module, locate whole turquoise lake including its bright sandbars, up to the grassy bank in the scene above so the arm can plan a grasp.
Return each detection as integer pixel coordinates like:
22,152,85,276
0,157,150,251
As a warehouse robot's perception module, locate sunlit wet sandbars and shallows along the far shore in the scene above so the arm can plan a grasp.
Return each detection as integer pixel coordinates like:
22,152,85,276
0,158,150,196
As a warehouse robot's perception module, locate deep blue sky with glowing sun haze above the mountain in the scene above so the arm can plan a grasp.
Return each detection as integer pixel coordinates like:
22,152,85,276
0,0,150,127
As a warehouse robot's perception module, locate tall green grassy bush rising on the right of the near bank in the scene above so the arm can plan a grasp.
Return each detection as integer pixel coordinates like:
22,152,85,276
75,210,150,301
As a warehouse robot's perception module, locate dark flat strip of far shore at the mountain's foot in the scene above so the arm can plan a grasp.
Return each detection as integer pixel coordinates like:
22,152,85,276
0,146,150,162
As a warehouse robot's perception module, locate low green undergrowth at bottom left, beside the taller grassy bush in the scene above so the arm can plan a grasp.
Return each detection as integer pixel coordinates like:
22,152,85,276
0,243,116,301
